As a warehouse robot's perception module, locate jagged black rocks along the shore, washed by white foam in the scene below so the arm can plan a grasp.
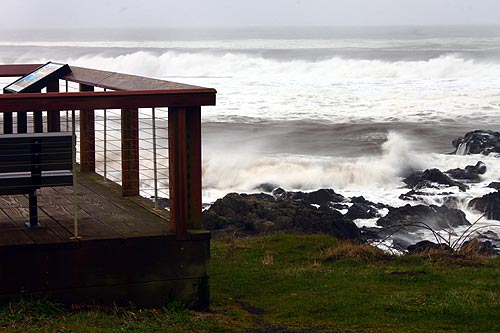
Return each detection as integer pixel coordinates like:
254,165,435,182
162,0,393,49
171,130,500,254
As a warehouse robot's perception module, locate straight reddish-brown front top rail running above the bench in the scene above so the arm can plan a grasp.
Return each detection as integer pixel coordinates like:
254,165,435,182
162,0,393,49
0,88,216,112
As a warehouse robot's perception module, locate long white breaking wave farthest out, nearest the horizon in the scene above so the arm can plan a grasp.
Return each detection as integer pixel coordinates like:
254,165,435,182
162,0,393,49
24,51,500,81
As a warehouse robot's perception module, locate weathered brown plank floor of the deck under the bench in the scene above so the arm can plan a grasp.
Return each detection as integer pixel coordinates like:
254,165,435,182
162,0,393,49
0,174,170,247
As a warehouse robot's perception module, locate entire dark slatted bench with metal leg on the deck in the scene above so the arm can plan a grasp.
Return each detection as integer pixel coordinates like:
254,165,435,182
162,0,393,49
0,132,73,228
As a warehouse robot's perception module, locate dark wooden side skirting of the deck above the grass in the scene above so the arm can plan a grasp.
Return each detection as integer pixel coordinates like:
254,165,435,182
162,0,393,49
0,233,210,309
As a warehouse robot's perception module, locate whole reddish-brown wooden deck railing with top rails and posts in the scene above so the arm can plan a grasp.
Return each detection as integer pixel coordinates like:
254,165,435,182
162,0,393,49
0,64,216,239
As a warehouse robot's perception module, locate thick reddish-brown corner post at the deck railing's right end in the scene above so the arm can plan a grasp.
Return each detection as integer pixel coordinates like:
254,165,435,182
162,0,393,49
168,107,202,239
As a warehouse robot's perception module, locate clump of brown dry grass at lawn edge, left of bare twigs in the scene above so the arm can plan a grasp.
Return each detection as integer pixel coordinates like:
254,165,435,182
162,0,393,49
320,242,390,261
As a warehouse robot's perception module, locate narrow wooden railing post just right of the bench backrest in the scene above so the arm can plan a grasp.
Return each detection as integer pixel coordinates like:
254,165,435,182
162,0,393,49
80,84,95,172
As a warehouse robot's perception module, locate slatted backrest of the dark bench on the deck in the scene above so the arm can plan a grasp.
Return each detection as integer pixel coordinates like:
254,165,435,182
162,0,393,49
0,132,73,173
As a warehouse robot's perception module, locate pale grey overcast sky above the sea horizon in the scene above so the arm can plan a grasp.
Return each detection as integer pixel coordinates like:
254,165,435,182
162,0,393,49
0,0,500,29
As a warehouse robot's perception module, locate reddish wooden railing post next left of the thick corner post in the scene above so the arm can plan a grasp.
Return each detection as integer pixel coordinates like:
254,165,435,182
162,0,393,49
121,109,139,197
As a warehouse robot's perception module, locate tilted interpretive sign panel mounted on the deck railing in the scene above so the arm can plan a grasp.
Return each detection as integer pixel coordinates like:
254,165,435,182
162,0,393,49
3,61,71,93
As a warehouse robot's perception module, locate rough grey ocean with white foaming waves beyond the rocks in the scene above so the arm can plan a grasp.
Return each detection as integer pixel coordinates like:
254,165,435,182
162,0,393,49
0,26,500,243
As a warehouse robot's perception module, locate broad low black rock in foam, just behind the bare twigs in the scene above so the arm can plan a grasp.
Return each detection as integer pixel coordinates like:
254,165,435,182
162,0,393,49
377,205,470,231
